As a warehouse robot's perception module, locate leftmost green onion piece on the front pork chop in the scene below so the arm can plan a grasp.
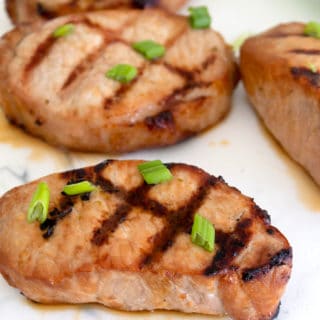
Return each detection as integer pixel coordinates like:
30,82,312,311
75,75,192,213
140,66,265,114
27,182,50,223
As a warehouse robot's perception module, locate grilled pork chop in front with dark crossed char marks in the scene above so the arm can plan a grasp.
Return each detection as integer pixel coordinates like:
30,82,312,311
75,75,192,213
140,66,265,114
0,160,292,320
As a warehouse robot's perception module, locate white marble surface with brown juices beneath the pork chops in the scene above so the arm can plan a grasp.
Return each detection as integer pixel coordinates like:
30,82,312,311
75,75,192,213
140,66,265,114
0,0,320,320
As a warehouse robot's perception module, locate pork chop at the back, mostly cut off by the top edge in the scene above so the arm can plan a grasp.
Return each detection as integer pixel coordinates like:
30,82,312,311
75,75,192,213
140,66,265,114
6,0,186,24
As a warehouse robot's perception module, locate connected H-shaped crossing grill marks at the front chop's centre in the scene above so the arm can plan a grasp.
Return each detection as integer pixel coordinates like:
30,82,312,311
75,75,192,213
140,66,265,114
87,164,219,268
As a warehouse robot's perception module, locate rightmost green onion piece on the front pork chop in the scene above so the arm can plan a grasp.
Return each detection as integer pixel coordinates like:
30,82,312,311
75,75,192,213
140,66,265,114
191,213,215,252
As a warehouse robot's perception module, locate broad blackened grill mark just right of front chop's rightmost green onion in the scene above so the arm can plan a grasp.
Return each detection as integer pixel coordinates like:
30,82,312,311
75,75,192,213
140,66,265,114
204,219,252,276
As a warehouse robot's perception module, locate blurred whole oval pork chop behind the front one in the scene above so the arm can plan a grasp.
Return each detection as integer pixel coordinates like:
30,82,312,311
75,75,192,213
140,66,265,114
0,9,236,152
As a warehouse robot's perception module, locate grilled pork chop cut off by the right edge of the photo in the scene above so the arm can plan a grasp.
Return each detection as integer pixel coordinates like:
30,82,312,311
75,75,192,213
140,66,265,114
240,23,320,184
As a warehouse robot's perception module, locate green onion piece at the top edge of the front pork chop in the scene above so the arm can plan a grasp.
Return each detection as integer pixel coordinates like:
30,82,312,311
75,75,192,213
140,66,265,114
138,160,172,184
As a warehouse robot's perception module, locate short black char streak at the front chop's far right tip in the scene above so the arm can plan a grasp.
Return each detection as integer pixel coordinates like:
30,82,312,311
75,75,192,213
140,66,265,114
242,248,292,282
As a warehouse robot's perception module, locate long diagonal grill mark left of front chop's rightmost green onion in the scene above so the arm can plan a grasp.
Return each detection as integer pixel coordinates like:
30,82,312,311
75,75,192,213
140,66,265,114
140,176,217,268
